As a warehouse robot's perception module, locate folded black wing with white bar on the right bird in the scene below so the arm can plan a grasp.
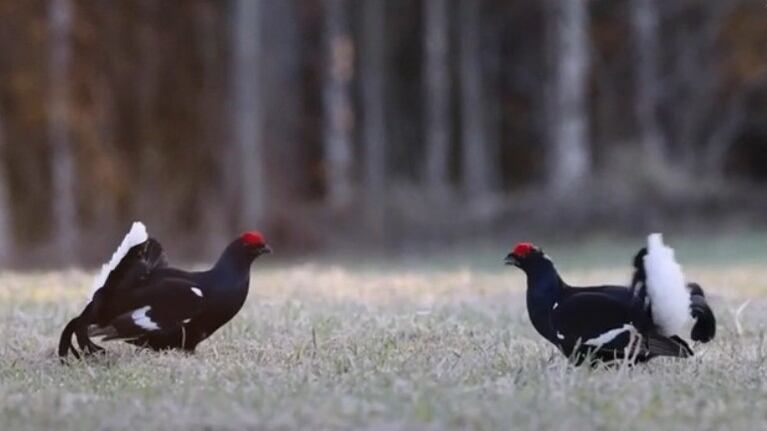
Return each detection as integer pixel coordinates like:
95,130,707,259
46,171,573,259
551,292,638,350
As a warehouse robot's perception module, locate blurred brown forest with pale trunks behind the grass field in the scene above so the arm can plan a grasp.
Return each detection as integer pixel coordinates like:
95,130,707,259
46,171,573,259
0,0,767,266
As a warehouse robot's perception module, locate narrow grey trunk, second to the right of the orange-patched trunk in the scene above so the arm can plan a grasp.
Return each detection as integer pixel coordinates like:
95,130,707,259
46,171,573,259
423,0,450,195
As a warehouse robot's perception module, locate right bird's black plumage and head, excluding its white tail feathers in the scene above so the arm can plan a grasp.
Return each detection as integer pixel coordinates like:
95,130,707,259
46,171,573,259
506,243,716,364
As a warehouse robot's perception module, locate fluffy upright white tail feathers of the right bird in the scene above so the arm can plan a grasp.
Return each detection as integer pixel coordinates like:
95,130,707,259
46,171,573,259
644,233,692,337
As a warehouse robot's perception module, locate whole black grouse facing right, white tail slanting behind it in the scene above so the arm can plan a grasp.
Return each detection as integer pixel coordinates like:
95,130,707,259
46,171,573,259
58,222,272,360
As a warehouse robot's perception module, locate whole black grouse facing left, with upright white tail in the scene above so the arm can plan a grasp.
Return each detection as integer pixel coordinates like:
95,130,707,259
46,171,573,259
504,234,716,366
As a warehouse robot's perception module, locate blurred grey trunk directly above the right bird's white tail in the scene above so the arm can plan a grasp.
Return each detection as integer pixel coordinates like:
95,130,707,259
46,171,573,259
630,0,668,162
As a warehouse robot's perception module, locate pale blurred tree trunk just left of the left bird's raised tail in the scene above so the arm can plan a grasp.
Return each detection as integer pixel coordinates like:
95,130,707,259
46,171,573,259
48,0,79,263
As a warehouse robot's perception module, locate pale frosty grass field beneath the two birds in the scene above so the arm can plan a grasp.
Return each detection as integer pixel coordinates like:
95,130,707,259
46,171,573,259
0,240,767,430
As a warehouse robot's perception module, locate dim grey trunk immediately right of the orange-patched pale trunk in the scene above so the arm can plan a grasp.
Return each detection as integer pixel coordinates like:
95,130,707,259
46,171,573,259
360,0,386,236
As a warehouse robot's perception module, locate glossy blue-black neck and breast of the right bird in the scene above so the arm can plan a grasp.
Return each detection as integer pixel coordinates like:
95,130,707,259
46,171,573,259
524,259,564,338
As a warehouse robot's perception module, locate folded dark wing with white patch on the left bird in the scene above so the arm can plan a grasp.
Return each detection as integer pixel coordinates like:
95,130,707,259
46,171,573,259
89,279,204,340
